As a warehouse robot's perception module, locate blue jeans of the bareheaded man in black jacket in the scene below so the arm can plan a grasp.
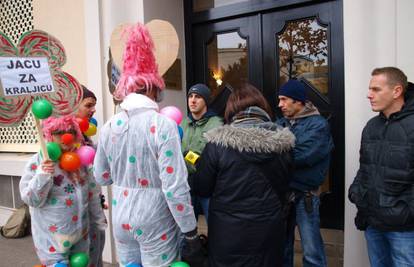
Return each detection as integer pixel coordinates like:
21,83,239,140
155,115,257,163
365,226,414,267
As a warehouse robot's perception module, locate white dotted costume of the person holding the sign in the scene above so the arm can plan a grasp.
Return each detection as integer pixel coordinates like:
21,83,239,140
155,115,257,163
20,154,106,266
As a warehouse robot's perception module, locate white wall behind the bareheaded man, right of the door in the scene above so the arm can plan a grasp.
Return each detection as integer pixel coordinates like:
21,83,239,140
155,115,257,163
343,0,414,266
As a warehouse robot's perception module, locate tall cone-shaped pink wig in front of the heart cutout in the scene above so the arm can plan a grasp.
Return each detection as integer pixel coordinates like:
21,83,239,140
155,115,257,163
114,23,165,100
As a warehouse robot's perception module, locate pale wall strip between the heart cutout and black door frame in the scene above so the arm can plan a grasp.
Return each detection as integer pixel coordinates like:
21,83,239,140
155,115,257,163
144,0,187,114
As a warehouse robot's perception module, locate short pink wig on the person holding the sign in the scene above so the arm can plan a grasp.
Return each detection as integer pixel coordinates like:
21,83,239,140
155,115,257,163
42,115,83,142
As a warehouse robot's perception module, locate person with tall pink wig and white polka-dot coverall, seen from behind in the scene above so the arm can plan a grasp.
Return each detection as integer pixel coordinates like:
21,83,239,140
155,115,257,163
94,24,204,267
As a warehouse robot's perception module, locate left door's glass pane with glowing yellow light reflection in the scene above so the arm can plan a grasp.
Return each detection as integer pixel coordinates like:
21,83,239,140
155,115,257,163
207,32,248,98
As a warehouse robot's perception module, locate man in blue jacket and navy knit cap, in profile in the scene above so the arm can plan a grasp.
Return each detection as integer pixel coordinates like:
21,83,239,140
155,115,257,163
277,80,333,267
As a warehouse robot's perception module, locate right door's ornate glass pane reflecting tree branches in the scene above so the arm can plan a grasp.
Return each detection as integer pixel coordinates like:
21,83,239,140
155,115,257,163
277,18,329,95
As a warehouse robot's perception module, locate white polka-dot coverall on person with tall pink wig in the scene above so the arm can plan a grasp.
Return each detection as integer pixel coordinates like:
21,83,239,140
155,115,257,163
94,94,196,267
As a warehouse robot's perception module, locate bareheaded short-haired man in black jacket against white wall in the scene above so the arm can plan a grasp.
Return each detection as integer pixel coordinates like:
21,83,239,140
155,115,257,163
349,67,414,266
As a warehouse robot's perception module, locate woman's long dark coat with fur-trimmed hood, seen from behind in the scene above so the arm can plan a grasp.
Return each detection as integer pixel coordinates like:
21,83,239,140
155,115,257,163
194,123,295,267
